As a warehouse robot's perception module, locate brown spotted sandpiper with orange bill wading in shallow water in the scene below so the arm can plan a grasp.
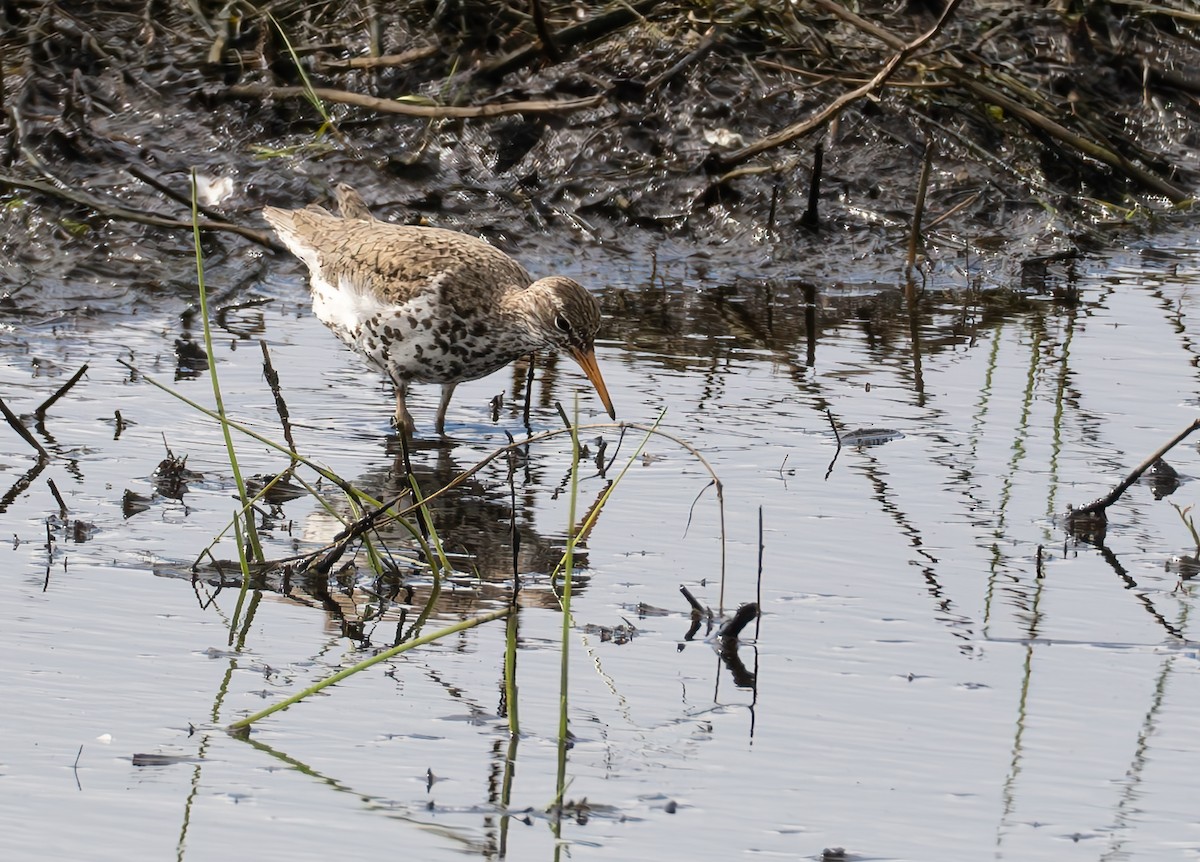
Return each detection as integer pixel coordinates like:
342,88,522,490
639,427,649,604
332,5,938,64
263,185,617,436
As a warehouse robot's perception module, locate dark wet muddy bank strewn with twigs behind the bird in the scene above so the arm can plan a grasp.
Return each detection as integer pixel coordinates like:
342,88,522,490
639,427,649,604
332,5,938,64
0,0,1200,315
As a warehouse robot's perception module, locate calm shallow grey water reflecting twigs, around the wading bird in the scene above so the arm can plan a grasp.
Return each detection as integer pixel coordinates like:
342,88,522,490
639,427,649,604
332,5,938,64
0,231,1200,862
